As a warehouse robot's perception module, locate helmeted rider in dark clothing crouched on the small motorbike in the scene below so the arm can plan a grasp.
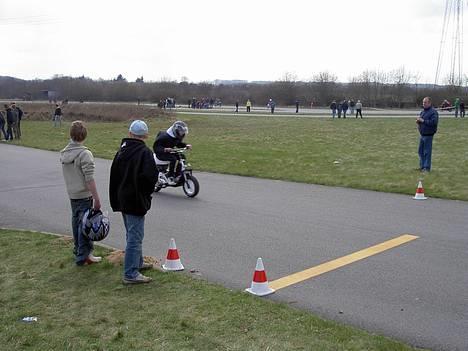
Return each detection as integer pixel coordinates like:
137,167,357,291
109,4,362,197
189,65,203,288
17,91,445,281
153,121,192,185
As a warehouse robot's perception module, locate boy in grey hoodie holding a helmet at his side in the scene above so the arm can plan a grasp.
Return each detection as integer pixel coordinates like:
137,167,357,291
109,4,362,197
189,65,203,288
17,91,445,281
60,121,102,266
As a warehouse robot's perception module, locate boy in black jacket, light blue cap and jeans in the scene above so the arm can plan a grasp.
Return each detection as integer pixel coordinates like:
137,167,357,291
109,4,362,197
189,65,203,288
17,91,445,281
109,120,158,284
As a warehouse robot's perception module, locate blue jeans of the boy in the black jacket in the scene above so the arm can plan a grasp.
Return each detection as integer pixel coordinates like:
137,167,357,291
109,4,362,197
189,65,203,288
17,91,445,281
122,213,145,279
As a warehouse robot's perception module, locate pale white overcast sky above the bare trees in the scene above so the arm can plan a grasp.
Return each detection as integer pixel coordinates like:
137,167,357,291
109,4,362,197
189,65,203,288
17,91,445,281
0,0,460,83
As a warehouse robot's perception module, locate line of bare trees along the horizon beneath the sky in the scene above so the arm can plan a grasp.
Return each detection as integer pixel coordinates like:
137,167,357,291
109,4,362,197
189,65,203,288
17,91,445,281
0,67,467,108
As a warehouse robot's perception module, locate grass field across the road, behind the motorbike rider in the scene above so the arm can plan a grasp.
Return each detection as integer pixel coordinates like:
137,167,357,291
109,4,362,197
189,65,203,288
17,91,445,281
14,115,468,201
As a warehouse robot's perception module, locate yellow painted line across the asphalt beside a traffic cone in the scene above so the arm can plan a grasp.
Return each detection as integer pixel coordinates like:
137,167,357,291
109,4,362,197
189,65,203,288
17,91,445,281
268,234,418,290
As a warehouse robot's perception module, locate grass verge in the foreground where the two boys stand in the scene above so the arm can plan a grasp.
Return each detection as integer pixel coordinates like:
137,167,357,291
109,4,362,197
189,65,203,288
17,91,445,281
0,230,424,351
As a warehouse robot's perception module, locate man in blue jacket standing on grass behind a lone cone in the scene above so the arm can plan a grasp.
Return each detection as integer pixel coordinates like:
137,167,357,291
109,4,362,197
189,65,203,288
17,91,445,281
416,96,439,172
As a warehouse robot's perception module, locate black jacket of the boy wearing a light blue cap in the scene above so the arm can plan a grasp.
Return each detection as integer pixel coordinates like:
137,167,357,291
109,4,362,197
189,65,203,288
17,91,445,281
109,138,158,216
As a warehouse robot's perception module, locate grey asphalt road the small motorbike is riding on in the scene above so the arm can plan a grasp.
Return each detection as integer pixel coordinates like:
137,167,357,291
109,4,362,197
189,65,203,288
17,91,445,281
0,143,468,350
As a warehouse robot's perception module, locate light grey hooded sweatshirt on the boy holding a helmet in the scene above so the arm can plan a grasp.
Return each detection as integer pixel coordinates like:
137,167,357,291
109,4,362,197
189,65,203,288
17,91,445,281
60,141,94,199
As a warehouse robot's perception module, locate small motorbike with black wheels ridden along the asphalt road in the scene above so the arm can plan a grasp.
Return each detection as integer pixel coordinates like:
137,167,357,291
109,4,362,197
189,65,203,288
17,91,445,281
154,147,200,197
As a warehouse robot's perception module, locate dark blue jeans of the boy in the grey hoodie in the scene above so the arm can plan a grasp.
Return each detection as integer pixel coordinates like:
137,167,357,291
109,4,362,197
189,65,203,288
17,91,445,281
70,197,94,265
